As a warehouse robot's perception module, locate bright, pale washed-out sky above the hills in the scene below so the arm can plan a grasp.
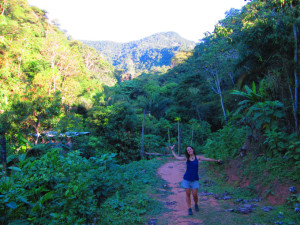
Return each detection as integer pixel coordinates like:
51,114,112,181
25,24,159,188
28,0,246,42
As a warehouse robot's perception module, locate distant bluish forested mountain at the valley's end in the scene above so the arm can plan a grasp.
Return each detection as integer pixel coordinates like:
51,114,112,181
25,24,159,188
83,32,195,80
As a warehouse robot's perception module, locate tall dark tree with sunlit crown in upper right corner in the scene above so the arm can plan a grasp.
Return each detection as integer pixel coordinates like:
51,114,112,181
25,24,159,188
232,0,300,132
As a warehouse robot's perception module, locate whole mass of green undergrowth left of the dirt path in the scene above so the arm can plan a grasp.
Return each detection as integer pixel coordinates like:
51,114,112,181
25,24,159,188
0,148,164,224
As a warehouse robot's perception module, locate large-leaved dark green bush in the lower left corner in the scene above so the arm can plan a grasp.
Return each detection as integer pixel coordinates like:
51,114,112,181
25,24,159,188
0,149,115,224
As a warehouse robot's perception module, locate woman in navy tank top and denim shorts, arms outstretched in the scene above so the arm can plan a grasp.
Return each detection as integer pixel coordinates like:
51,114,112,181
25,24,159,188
171,145,221,215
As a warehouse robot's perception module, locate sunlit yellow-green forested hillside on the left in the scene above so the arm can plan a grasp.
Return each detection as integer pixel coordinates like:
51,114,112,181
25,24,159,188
0,0,116,109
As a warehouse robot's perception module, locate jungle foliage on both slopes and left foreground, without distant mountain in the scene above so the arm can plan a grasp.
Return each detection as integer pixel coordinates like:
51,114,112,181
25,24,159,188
0,0,300,224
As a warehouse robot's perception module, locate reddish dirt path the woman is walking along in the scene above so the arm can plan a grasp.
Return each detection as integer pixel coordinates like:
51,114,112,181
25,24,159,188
154,161,250,225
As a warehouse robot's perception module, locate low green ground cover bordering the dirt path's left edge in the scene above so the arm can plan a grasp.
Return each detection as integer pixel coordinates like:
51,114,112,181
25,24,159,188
99,160,164,225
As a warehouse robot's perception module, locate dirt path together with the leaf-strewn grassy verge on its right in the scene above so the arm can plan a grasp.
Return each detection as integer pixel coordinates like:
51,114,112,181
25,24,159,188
146,160,299,225
